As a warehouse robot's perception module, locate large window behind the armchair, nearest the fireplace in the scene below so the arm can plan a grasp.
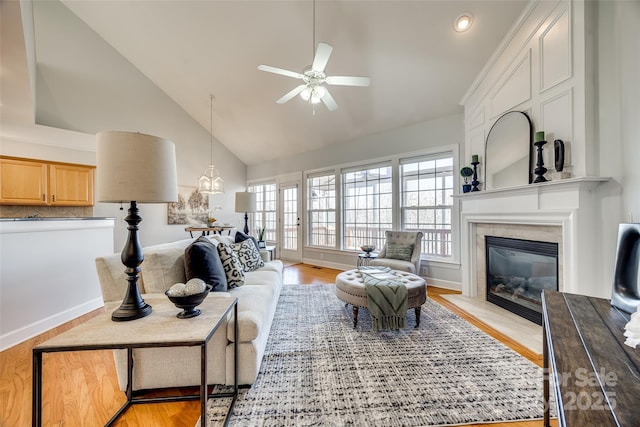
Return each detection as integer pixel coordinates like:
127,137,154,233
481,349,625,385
400,153,453,258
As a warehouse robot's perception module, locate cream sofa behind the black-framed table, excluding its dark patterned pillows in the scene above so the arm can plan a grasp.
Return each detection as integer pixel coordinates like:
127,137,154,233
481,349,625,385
96,235,283,390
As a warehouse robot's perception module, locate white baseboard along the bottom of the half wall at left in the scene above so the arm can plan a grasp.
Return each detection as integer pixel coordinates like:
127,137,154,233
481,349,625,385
0,298,104,351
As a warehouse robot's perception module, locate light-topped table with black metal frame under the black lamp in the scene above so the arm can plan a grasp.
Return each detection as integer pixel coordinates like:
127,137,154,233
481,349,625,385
32,294,238,426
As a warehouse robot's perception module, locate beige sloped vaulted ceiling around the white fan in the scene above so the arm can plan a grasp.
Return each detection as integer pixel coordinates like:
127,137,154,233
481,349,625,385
30,0,526,165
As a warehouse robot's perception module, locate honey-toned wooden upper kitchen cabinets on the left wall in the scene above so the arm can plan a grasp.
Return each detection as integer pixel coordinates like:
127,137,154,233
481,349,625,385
0,157,94,206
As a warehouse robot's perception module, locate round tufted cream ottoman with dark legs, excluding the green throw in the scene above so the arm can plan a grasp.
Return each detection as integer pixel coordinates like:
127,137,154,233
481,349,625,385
336,270,427,328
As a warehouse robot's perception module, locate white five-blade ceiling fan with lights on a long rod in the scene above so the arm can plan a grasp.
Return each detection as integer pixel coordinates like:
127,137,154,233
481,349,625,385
258,43,370,111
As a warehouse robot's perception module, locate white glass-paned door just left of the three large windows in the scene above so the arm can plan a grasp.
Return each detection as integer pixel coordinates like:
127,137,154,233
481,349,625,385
278,182,302,262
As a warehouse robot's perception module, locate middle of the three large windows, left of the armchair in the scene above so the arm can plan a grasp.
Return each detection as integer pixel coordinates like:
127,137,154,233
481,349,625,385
342,164,393,250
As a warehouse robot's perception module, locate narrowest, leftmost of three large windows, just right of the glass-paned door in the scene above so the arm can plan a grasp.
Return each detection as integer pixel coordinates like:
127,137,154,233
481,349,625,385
307,172,336,248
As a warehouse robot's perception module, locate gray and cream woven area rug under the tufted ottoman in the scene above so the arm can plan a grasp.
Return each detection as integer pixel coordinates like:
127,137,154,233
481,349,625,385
198,285,556,426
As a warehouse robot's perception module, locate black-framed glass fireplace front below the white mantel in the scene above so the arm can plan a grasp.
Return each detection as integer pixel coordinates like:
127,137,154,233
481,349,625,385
485,236,558,325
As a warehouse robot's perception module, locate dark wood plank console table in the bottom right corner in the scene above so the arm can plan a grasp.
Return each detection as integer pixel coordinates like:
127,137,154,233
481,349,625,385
542,291,640,427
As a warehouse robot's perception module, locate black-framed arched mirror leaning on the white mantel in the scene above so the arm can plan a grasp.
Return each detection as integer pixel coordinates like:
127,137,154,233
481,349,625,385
484,111,533,190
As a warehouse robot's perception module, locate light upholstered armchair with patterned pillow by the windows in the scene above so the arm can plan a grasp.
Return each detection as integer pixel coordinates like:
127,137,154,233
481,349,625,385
369,231,424,275
